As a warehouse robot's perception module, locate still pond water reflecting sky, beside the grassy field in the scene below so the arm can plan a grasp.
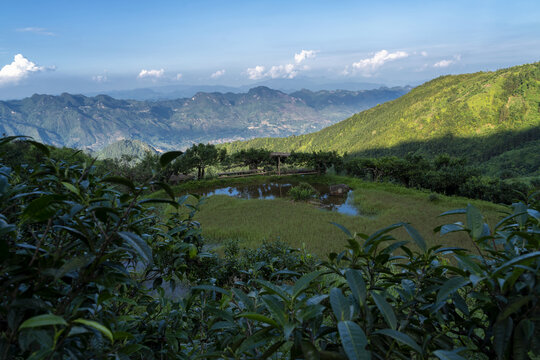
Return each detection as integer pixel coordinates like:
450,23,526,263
193,182,360,216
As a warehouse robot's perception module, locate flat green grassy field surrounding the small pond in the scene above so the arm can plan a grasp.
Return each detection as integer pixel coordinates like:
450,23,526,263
160,176,504,257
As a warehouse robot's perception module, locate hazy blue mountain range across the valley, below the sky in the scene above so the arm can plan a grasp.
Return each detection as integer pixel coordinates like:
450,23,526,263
0,86,409,150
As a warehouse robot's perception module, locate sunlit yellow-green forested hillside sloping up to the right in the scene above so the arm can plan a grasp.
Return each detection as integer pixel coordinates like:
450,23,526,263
221,62,540,176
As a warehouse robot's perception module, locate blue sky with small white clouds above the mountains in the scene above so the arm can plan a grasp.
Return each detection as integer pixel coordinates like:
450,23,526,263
0,0,540,99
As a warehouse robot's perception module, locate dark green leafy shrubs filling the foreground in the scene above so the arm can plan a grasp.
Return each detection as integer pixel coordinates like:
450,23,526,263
0,140,540,360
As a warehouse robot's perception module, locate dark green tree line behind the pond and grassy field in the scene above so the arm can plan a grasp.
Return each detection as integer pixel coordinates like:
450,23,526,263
5,141,540,204
